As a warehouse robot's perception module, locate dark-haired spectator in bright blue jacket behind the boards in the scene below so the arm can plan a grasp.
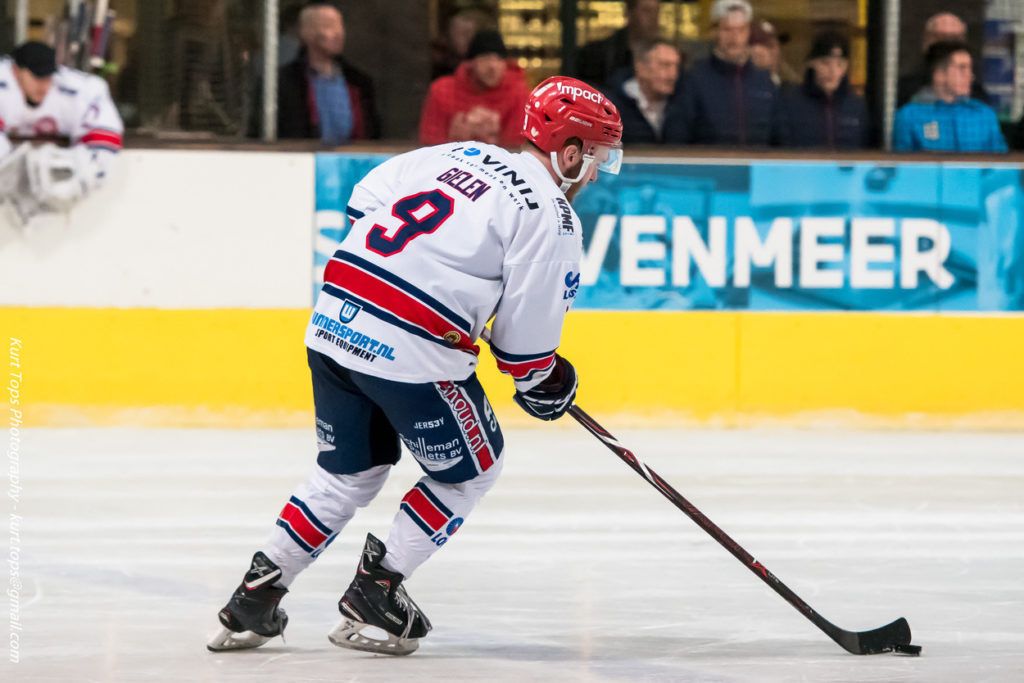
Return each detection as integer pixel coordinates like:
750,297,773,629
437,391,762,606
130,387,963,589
893,42,1007,153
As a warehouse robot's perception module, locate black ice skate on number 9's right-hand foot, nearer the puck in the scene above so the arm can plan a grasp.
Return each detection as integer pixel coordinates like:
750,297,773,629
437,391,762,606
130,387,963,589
328,533,431,654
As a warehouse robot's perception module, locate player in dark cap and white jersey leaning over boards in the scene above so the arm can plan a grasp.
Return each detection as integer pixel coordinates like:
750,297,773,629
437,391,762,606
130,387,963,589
0,42,124,223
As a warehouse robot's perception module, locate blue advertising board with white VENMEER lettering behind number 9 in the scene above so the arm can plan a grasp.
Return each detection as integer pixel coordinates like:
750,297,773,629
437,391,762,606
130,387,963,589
315,154,1024,311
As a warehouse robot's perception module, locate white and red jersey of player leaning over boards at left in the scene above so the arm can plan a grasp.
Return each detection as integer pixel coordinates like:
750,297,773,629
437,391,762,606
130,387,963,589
0,57,124,156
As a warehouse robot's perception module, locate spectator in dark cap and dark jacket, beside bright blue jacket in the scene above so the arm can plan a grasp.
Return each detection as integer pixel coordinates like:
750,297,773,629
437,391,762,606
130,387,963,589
782,32,871,150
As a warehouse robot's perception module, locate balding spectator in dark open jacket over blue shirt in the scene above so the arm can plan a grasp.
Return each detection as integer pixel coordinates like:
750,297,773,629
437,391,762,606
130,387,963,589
258,2,380,146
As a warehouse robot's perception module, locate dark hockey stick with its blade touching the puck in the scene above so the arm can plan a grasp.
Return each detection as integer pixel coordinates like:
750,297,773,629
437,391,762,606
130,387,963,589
481,328,921,655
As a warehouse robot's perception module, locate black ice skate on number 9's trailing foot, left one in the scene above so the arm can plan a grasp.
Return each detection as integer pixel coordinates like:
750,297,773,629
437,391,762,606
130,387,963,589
206,552,288,652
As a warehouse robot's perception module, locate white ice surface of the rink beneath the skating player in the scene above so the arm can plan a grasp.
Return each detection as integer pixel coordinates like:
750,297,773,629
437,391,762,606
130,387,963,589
0,428,1024,683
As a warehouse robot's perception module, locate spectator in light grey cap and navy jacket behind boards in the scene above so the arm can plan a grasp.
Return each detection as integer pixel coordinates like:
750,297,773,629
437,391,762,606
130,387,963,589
665,0,782,145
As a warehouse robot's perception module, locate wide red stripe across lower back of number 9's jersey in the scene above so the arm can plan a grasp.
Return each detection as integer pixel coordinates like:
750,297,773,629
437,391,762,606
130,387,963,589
324,260,480,355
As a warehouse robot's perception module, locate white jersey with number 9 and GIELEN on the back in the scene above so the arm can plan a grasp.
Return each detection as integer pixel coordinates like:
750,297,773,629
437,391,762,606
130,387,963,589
306,142,583,390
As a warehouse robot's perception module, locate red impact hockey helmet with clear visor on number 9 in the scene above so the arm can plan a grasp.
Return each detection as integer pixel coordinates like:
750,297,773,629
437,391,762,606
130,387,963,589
522,76,623,191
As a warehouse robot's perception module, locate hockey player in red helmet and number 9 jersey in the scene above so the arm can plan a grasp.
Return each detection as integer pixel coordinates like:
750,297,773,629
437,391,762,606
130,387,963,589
209,77,623,654
